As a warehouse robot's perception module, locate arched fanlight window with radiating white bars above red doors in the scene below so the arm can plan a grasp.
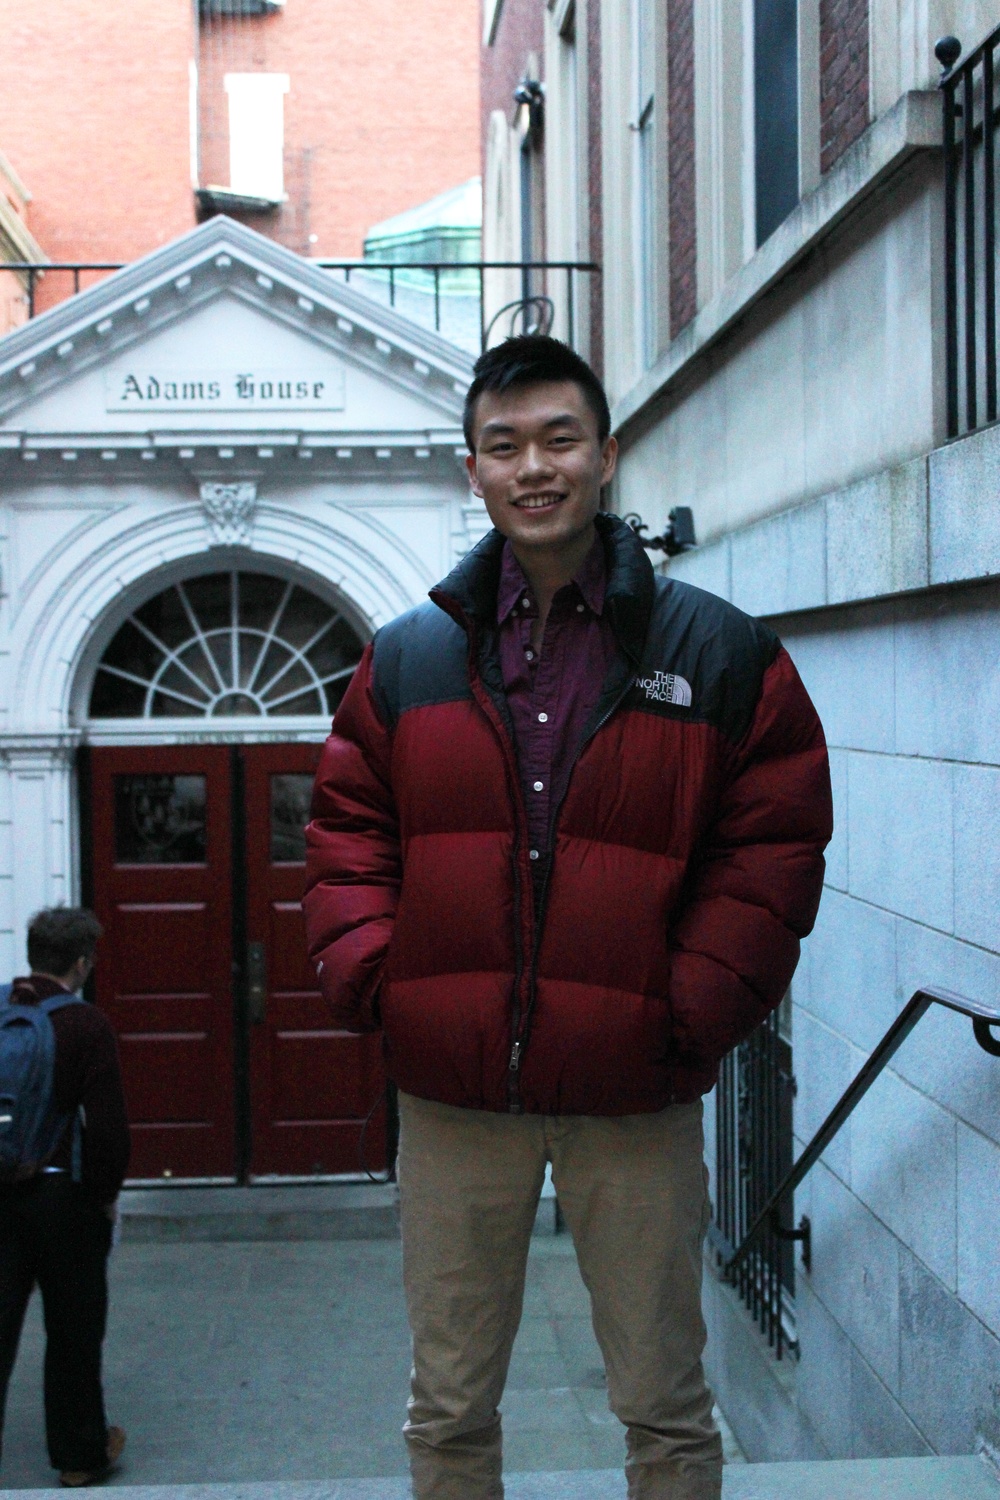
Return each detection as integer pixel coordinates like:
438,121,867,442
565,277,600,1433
90,573,363,719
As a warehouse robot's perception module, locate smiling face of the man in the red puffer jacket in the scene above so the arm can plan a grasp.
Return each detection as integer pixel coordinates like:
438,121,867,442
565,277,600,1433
466,381,618,558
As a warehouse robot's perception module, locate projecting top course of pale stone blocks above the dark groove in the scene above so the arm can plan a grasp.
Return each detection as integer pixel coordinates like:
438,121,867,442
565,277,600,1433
669,425,1000,618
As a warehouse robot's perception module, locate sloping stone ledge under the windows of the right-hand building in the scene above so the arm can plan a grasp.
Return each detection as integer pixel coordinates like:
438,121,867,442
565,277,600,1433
612,90,943,443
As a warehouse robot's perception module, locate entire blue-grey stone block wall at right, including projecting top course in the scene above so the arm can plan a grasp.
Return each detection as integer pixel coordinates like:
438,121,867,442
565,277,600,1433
692,417,1000,1460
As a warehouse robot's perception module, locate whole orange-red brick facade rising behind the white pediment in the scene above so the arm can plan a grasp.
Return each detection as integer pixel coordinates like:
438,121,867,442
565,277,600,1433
0,0,481,295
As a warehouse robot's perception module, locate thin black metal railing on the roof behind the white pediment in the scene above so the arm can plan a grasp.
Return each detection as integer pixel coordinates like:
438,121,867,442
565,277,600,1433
0,260,601,353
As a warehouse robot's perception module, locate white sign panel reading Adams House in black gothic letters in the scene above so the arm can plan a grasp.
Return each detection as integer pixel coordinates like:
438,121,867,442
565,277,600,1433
103,372,345,413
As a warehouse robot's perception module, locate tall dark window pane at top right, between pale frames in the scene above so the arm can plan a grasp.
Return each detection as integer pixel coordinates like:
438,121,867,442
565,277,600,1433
754,0,799,245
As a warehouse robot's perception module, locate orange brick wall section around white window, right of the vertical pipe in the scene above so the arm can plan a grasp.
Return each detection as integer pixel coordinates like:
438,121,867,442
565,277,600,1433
199,0,481,258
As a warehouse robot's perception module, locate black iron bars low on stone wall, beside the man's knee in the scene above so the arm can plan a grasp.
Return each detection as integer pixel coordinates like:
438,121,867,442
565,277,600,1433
709,999,799,1359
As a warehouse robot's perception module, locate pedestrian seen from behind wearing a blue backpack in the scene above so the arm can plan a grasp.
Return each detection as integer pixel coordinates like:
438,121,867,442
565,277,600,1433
0,906,129,1488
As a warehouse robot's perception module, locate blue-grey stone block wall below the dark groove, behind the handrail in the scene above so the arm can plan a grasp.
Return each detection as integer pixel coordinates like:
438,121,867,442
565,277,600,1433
784,582,1000,1457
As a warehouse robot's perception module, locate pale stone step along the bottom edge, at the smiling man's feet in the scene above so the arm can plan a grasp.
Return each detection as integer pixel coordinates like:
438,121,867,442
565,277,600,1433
0,1458,1000,1500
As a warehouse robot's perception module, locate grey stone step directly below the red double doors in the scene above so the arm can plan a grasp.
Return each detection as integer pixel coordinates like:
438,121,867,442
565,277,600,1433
118,1182,556,1244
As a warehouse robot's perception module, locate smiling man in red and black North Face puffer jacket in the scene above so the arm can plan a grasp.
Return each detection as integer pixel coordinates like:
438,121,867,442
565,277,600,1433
306,338,832,1500
